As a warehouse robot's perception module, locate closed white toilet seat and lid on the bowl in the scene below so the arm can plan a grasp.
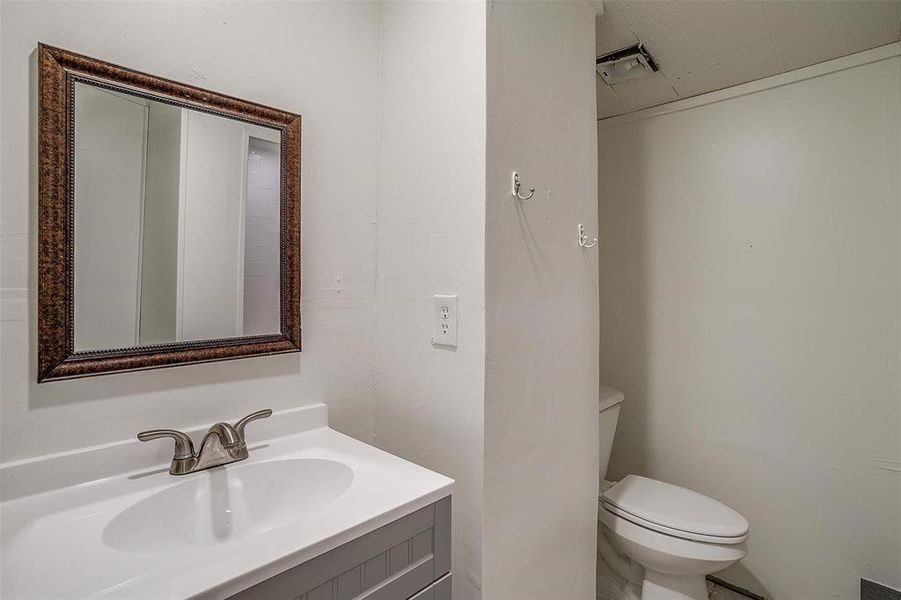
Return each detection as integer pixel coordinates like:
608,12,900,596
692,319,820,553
601,475,749,545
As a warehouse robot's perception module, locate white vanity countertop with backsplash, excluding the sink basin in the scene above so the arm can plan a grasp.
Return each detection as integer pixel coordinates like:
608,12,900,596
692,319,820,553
0,405,453,600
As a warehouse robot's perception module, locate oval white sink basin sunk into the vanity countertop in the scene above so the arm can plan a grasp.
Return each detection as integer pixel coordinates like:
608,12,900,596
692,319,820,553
102,458,354,553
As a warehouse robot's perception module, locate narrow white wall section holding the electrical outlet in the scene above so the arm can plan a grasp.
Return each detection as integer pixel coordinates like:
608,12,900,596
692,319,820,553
375,2,485,600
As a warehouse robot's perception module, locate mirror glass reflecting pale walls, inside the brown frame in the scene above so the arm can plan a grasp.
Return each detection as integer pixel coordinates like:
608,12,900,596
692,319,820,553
74,82,281,351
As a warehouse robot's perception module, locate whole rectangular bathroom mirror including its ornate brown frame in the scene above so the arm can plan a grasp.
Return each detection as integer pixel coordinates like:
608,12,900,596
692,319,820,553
38,45,301,381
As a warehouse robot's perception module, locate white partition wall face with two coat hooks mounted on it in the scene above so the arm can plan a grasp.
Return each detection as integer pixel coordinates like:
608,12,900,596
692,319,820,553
483,1,598,600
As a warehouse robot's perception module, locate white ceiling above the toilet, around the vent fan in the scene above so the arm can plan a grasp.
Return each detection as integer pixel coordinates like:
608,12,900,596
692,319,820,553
596,0,901,119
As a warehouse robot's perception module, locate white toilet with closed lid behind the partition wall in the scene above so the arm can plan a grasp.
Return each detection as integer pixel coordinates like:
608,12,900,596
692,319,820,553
598,387,748,600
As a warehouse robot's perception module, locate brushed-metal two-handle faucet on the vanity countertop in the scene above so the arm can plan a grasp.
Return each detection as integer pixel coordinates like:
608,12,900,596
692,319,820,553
138,408,272,475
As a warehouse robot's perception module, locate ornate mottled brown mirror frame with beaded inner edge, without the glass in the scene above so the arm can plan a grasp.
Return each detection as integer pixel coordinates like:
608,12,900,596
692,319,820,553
37,44,301,382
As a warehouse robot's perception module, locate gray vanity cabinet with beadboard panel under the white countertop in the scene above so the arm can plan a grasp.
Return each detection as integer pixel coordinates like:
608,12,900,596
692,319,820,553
229,496,451,600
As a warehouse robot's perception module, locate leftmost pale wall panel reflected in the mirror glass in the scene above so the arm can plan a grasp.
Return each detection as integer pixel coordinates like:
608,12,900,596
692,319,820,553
75,84,147,350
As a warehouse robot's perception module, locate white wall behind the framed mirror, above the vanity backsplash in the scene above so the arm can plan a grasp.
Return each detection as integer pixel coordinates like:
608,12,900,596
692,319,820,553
0,2,380,460
